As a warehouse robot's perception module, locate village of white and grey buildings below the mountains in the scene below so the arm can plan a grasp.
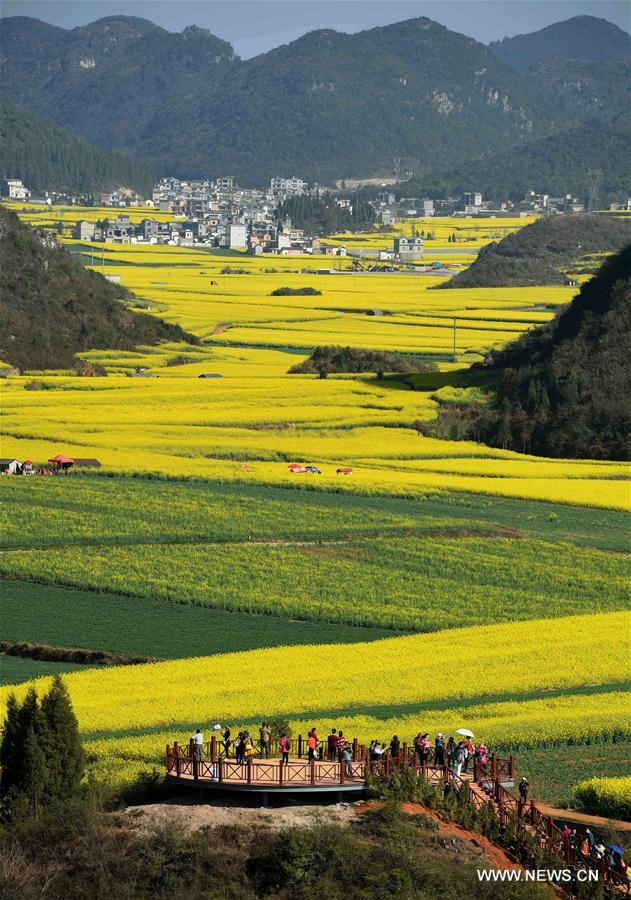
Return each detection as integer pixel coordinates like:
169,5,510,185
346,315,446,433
0,175,631,262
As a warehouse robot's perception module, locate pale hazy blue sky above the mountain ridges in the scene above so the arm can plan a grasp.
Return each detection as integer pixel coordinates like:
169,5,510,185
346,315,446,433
0,0,631,57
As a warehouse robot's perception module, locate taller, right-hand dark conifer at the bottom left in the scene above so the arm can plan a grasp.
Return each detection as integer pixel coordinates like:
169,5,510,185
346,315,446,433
42,675,85,799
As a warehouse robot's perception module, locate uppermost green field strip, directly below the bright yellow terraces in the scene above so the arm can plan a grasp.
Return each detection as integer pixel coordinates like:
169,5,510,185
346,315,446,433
0,474,629,550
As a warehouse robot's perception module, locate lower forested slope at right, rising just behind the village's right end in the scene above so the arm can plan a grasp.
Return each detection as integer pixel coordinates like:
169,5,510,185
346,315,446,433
402,116,631,205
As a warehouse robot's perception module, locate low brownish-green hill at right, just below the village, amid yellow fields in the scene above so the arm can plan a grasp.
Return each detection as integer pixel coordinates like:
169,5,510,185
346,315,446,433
441,213,631,289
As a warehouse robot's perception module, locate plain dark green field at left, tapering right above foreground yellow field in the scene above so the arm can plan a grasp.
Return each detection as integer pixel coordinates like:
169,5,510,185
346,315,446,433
0,579,392,684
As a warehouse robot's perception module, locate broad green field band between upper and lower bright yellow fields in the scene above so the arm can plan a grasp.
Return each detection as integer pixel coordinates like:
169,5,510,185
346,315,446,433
0,476,629,644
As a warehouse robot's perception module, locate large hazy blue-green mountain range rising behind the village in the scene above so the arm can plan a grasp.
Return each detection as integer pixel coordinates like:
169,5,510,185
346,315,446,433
1,16,557,183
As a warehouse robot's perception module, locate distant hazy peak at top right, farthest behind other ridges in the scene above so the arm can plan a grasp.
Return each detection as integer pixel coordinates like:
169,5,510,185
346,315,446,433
489,16,631,72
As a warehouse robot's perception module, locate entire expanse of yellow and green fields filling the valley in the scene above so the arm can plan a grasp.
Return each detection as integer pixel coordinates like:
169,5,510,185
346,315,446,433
0,209,631,800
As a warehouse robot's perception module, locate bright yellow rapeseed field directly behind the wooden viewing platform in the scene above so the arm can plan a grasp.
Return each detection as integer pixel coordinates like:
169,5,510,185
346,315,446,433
0,612,629,792
